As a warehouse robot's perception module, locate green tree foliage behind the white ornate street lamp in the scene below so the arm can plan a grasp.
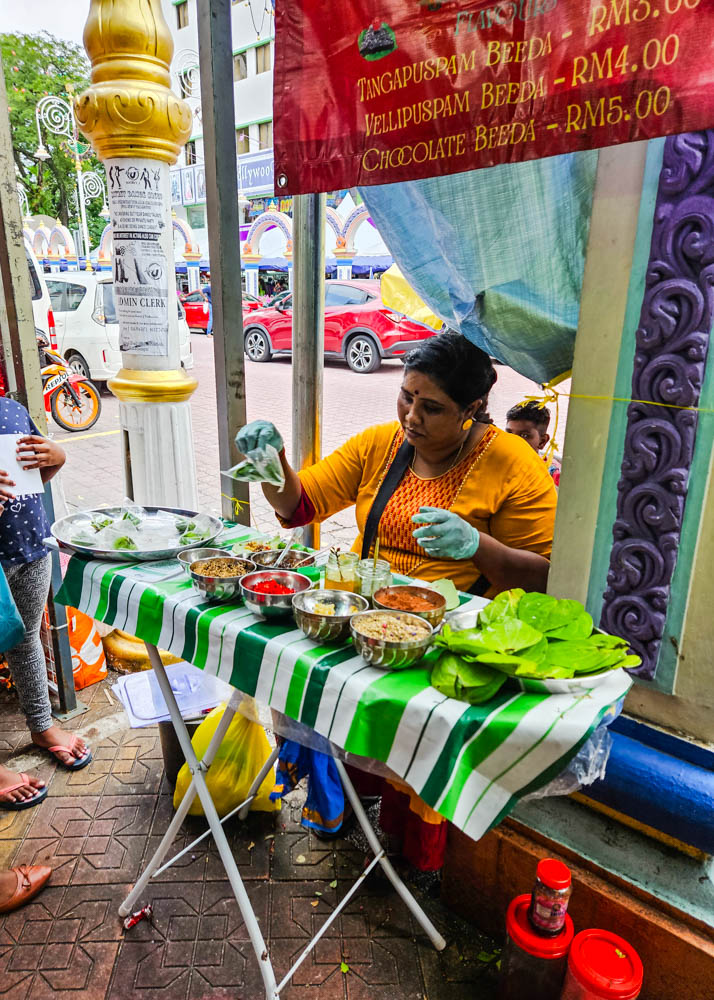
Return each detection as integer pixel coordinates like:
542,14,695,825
0,31,106,252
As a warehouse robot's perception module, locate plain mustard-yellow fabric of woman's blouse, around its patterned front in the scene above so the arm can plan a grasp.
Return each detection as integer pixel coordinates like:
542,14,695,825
292,421,557,591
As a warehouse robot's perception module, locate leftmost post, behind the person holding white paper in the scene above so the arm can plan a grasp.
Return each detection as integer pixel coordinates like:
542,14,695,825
0,58,80,719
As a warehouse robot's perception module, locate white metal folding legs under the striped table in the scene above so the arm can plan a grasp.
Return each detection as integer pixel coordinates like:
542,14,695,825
119,642,446,1000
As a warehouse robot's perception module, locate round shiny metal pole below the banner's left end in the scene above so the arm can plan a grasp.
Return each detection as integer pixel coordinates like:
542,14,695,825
293,194,327,548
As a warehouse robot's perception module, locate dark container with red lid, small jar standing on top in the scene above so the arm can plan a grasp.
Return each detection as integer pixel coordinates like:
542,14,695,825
499,892,574,1000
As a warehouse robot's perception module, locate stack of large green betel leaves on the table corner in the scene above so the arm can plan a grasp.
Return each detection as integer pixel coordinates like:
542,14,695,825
431,590,641,705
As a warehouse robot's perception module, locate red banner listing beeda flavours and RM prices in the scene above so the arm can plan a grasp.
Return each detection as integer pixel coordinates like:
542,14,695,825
274,0,714,194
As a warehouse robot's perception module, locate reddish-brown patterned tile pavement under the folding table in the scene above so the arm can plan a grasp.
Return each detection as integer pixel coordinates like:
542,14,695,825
0,682,496,1000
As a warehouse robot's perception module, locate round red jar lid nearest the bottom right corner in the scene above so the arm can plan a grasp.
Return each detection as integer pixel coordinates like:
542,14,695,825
568,929,643,1000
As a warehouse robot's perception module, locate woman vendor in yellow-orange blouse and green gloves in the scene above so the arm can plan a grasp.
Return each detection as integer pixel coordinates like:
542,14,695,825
236,333,557,870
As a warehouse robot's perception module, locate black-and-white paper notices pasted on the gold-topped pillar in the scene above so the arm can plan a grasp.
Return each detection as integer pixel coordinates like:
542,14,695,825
106,159,176,357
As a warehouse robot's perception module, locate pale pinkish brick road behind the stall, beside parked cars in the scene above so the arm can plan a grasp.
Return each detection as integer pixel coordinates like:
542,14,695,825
50,334,567,545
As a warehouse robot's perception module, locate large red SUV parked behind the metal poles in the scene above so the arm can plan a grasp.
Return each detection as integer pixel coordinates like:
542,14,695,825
243,280,436,375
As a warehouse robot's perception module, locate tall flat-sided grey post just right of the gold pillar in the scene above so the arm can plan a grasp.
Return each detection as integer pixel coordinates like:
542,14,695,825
197,0,250,524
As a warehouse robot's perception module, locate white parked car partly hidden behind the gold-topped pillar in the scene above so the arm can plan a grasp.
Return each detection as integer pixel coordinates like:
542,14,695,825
45,271,193,382
